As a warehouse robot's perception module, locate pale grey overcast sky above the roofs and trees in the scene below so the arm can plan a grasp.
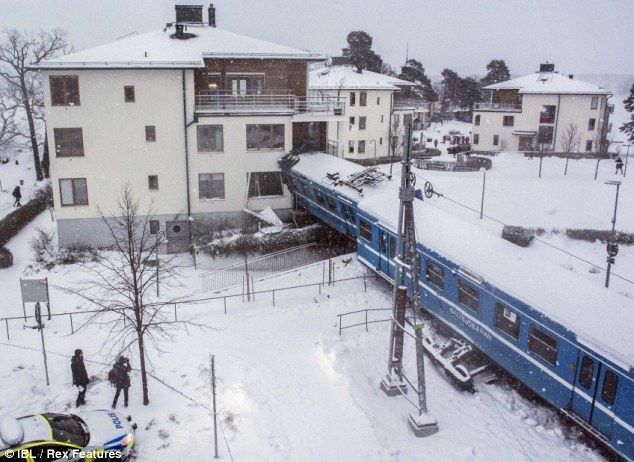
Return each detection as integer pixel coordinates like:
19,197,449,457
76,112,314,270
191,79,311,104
0,0,634,77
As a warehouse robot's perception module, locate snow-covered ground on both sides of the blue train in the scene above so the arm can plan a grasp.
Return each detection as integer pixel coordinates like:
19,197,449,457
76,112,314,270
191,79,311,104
0,132,634,462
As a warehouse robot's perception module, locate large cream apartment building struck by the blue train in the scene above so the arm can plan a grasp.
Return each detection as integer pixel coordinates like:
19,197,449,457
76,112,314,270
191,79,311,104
36,6,346,252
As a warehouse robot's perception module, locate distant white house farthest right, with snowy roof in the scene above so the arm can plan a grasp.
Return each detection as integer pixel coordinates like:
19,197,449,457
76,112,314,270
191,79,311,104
472,64,613,152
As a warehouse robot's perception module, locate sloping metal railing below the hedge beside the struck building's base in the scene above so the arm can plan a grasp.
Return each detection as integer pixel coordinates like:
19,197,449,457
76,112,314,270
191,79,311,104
200,243,322,292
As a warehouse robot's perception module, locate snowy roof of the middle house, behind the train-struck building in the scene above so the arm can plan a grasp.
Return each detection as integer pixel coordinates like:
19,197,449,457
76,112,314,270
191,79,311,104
308,66,414,90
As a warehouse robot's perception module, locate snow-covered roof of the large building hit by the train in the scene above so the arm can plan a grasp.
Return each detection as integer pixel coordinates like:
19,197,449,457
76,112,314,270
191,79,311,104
33,25,324,69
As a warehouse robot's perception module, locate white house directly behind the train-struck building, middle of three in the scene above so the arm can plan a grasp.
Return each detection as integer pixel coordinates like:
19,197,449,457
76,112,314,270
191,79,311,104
308,58,429,160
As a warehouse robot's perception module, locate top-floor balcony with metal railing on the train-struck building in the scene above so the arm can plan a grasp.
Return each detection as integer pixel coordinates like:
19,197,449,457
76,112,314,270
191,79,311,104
194,91,345,120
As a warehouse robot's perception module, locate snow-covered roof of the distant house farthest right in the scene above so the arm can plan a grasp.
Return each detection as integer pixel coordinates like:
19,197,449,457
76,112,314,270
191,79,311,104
484,72,611,95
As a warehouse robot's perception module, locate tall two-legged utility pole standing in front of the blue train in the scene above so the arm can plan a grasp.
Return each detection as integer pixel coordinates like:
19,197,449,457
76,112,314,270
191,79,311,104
381,121,438,437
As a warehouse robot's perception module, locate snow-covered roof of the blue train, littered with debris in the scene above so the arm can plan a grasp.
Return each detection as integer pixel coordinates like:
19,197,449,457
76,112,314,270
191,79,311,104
292,153,634,376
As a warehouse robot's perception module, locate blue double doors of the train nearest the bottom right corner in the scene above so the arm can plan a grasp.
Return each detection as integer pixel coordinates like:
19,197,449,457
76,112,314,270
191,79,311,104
571,353,619,438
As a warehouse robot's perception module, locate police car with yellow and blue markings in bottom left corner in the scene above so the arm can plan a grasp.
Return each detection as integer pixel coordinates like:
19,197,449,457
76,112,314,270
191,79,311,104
0,410,136,462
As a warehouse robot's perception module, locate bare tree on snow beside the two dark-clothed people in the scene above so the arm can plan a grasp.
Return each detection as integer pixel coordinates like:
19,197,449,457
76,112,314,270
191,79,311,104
60,185,205,405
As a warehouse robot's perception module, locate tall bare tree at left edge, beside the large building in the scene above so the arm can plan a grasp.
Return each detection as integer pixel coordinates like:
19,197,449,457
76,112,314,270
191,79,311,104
0,29,69,181
